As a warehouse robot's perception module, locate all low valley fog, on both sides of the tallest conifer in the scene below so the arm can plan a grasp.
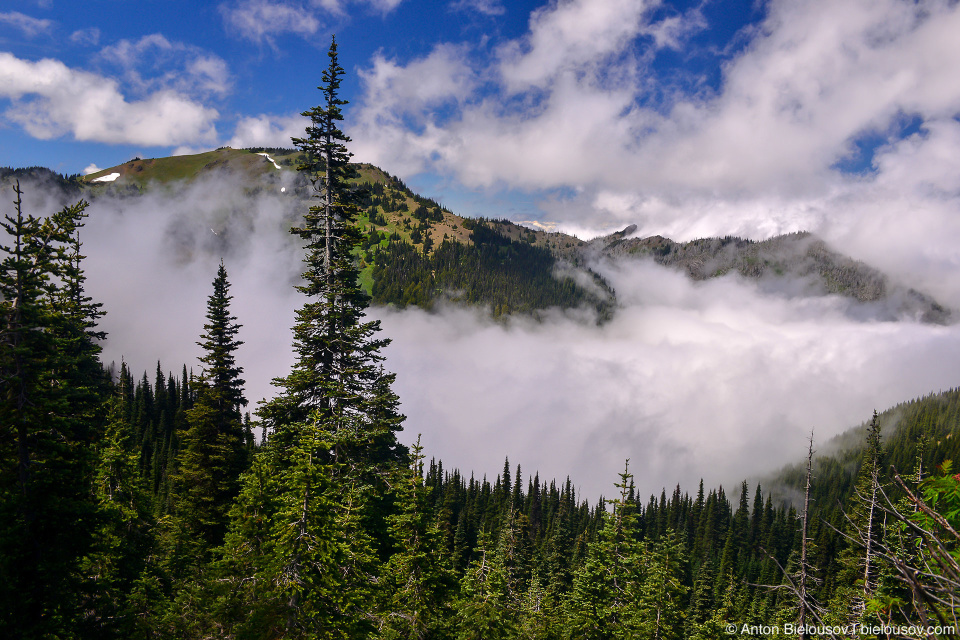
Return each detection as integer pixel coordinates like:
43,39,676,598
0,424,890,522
28,177,960,498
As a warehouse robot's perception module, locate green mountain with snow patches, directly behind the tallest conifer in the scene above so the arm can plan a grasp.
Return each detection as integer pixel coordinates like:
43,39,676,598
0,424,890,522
80,148,615,317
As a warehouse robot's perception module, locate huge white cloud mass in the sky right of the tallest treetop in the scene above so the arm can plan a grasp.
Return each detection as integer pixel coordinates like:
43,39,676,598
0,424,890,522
350,0,960,306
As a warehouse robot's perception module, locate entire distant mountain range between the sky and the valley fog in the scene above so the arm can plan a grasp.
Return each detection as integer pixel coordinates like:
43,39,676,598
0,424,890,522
0,147,953,324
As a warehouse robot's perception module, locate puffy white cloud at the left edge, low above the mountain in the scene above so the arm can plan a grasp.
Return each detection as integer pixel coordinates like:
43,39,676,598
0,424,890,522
0,53,218,146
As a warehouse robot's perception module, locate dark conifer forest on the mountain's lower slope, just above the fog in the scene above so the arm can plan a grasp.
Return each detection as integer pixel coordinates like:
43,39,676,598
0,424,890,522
372,221,612,317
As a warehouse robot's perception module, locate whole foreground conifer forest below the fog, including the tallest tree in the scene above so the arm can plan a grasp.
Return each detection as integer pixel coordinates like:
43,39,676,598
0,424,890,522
0,42,960,640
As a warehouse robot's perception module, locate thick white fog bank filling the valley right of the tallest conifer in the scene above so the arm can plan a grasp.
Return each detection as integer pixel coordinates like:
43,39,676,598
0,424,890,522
380,263,960,497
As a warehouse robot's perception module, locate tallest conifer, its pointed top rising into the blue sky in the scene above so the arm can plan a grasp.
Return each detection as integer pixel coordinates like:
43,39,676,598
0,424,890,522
260,35,400,444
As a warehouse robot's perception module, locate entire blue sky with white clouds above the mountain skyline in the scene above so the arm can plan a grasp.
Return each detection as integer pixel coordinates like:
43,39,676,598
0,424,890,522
0,0,960,239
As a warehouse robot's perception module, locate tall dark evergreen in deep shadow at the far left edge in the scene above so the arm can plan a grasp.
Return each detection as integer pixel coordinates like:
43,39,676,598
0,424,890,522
0,184,103,638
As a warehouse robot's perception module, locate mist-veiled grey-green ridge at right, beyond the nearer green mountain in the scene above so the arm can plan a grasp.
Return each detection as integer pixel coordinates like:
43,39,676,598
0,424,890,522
584,227,951,324
